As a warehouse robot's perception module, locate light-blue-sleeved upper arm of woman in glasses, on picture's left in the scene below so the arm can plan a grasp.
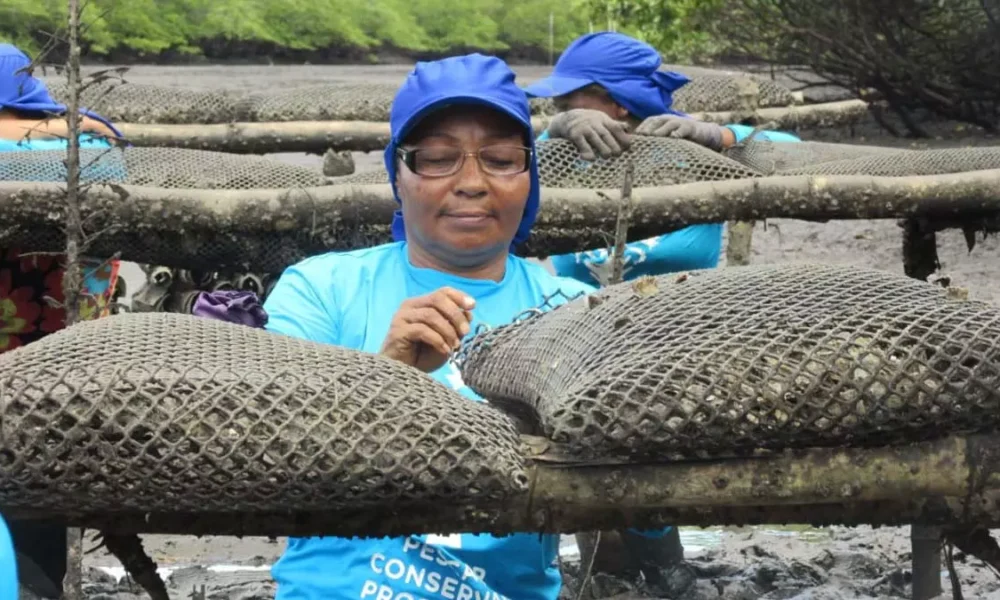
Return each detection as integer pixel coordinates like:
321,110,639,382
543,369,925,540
264,261,340,344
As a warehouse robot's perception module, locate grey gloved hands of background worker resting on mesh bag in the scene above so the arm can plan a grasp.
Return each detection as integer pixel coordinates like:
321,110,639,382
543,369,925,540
548,108,736,160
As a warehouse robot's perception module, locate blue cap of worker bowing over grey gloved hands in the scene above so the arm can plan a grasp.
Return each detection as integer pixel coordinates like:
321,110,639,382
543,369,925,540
524,31,690,119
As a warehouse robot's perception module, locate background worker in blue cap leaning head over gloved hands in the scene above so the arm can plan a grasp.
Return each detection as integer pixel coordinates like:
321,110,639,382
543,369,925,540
525,32,800,285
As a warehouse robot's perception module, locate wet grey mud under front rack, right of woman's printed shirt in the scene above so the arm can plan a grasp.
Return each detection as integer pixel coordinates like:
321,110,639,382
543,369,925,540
559,527,1000,600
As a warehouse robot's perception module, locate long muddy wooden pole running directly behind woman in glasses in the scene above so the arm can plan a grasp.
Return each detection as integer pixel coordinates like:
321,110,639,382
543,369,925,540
0,170,1000,273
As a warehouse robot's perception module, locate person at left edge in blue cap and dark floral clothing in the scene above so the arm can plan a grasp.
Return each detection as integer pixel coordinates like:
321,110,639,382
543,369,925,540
0,44,121,598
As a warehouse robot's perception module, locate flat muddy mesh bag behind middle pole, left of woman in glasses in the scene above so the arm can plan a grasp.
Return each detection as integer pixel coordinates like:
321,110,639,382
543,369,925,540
0,147,327,189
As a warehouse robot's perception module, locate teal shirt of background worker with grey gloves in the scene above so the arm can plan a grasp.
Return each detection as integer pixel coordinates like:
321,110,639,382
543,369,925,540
536,125,801,286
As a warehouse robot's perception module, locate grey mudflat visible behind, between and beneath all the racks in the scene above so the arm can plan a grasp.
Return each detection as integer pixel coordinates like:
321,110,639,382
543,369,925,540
26,65,1000,600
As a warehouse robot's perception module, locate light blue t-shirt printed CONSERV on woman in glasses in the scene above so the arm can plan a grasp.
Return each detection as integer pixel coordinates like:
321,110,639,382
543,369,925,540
264,242,592,600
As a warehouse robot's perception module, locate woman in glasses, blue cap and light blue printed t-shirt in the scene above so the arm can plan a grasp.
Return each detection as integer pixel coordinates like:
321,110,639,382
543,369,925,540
264,54,591,600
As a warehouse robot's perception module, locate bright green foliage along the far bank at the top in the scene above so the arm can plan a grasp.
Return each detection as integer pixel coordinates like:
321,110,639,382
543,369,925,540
0,0,716,62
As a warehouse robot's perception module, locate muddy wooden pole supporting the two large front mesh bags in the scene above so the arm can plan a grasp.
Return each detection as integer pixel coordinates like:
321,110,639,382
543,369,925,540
4,436,1000,537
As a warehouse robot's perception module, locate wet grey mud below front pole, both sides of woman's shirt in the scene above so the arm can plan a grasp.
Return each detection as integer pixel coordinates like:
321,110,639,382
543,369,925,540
60,527,1000,600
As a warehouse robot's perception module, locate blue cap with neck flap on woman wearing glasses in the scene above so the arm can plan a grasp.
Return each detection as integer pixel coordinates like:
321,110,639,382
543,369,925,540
385,54,541,247
